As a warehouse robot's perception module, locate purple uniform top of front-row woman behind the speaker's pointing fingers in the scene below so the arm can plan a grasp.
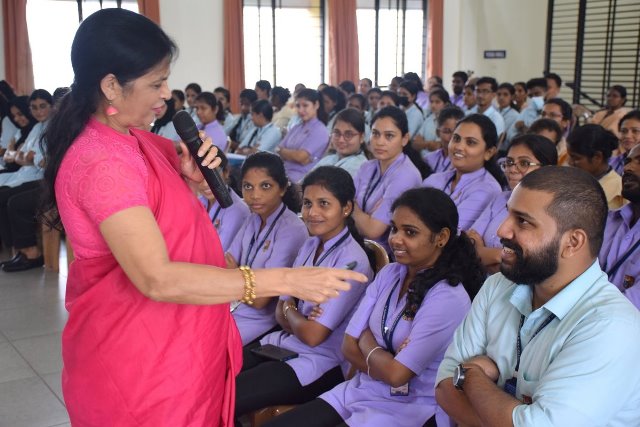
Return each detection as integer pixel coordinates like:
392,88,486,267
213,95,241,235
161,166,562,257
260,228,373,386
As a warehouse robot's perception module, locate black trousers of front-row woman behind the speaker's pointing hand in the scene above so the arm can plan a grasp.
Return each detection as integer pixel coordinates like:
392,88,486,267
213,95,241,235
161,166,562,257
236,346,344,417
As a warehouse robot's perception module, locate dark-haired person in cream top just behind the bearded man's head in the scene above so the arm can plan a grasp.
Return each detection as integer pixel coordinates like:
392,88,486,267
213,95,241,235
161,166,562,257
567,124,626,210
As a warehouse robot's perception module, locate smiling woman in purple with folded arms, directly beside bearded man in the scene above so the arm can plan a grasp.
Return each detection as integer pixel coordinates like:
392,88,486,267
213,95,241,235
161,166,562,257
265,188,483,427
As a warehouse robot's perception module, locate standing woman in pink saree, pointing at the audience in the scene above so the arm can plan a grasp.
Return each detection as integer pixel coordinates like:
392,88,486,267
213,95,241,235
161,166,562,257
45,9,366,426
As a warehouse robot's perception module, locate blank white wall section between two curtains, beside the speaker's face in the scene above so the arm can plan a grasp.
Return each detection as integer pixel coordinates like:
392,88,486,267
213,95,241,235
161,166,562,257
160,0,224,91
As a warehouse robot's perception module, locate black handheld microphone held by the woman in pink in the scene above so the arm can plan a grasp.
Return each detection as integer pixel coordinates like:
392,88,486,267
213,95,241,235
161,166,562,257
173,110,233,208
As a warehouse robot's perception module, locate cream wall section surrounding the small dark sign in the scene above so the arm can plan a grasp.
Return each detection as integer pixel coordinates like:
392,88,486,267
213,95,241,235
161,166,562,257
443,0,547,88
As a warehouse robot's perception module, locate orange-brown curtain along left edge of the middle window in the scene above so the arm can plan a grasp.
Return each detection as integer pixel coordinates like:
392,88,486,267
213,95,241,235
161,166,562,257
224,0,245,111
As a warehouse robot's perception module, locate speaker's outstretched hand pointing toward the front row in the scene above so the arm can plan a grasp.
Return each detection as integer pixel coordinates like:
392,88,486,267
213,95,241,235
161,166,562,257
284,267,368,304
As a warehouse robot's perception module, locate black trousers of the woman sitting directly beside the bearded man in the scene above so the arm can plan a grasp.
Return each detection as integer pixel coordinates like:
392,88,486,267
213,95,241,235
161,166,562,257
263,399,346,427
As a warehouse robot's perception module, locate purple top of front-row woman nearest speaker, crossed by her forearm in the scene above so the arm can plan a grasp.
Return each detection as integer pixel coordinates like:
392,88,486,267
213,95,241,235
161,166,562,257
228,203,309,345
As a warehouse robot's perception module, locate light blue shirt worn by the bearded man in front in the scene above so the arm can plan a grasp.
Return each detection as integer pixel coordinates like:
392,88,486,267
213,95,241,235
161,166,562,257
436,261,640,427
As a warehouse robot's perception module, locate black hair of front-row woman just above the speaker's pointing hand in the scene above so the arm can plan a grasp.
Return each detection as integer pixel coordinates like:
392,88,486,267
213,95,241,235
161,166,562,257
302,166,365,254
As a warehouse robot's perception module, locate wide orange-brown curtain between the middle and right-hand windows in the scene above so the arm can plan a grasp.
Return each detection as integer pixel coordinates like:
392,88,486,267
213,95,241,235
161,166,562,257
327,0,360,85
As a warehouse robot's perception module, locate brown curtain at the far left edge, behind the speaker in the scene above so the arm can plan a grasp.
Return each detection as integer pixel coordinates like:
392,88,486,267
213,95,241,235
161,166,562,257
2,0,34,95
